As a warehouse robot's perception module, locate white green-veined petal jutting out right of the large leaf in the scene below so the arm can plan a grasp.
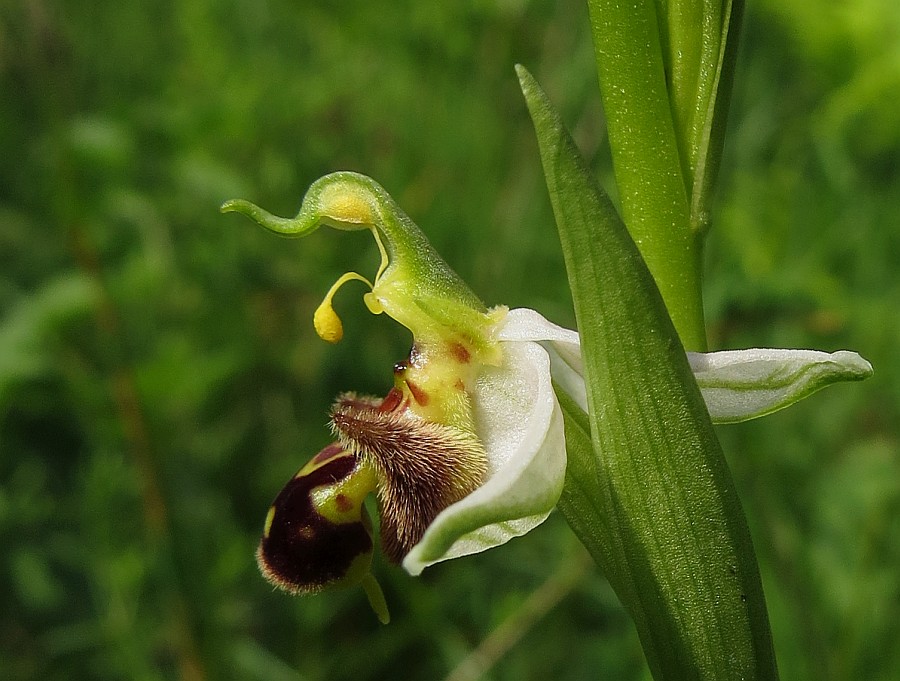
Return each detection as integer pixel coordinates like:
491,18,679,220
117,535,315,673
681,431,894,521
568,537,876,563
688,348,872,423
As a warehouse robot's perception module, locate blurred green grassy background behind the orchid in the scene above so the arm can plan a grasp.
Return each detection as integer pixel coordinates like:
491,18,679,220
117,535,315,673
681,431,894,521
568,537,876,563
0,0,900,681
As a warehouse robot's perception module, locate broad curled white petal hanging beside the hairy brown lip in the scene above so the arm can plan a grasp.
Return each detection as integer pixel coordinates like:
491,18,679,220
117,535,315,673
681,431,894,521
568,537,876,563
403,342,566,575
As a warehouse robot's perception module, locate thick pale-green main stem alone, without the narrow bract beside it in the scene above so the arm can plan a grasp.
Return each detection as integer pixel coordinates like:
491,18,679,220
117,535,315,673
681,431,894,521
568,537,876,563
588,0,707,351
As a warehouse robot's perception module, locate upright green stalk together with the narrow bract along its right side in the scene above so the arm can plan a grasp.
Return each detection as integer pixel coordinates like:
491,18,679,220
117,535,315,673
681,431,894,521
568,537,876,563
588,0,743,351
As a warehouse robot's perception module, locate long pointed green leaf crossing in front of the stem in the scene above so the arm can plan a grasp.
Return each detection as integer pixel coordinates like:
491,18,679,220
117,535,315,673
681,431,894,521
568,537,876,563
518,67,777,681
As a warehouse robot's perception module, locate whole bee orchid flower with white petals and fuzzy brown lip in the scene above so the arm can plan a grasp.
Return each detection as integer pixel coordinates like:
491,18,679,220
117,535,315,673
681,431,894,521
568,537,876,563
222,172,871,621
